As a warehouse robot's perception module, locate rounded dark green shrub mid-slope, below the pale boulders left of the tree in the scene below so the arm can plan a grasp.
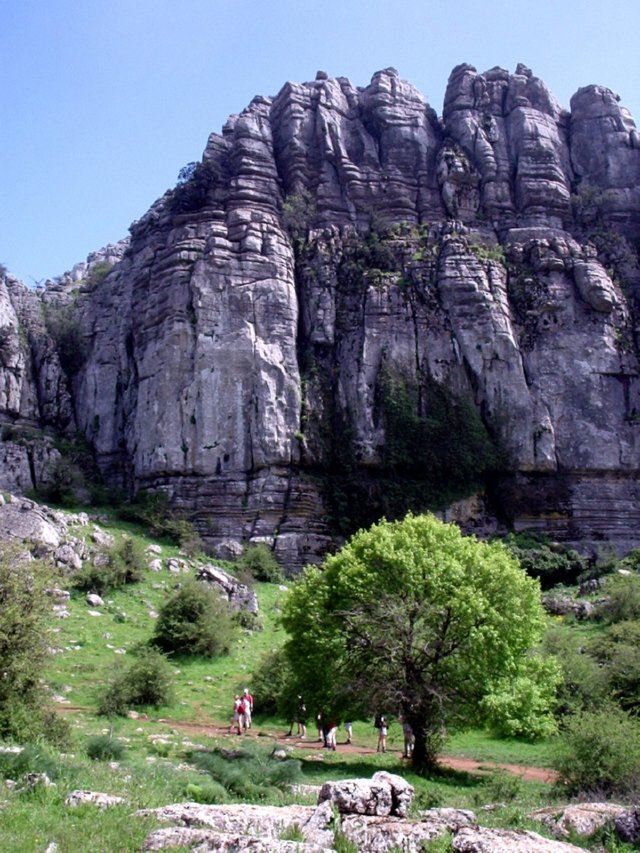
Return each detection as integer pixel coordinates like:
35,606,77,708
152,580,235,657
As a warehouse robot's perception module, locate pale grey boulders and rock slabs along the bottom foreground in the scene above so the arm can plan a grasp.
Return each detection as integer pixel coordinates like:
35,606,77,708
67,771,640,853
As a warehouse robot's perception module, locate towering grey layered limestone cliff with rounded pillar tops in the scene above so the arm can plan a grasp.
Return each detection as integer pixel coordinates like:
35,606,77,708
0,65,640,570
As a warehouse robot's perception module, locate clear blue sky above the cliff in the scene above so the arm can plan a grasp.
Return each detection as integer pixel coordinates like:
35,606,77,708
0,0,640,284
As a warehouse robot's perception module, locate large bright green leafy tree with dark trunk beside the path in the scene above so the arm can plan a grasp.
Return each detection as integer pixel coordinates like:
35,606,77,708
282,515,557,768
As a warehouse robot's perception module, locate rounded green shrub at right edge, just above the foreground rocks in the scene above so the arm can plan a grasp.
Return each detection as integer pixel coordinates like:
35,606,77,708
554,706,640,796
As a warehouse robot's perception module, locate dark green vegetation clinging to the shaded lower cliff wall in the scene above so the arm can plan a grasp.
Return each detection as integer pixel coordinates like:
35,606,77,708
324,370,504,535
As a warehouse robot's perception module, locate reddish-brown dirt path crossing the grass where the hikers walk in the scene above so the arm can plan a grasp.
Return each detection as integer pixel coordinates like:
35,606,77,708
56,705,557,784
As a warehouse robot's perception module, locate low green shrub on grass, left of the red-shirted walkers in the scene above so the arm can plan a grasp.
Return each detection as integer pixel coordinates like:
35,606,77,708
98,649,173,716
